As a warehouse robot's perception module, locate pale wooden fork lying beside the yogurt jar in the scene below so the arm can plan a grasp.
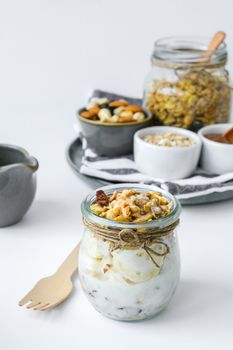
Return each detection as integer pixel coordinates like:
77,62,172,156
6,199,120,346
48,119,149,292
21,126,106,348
19,244,79,311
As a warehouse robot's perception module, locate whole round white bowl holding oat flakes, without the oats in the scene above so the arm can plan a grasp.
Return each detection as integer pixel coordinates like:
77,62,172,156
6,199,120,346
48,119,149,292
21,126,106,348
134,126,201,180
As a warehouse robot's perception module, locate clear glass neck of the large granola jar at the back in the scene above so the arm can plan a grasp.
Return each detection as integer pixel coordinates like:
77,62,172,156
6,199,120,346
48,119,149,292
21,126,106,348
151,37,227,68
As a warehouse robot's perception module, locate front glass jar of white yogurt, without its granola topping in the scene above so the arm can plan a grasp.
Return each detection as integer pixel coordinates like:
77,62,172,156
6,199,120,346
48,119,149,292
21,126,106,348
79,184,181,321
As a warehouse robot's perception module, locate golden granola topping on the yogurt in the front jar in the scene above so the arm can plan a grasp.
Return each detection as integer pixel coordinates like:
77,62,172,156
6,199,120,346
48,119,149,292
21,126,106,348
91,189,173,223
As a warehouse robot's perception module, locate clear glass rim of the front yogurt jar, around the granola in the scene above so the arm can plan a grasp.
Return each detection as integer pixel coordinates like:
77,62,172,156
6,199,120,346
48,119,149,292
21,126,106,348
81,183,181,229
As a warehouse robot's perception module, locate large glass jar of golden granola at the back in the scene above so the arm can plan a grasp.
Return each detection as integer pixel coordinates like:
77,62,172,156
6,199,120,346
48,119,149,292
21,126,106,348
144,37,231,131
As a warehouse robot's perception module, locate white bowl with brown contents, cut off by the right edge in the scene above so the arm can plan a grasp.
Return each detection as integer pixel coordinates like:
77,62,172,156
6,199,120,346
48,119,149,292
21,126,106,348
198,123,233,175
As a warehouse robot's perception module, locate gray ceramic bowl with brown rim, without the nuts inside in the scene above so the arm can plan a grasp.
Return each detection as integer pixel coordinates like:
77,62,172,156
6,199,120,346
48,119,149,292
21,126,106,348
77,108,152,157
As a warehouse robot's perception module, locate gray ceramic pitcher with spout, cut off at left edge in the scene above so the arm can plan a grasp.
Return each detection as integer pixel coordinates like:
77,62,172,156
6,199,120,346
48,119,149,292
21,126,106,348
0,144,39,227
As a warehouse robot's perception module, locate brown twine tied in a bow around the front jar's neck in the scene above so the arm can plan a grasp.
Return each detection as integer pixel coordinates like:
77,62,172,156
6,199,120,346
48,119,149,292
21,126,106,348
83,218,180,268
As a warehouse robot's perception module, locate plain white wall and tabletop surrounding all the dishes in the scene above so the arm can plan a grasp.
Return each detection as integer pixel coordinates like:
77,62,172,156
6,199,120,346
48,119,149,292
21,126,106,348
0,0,233,350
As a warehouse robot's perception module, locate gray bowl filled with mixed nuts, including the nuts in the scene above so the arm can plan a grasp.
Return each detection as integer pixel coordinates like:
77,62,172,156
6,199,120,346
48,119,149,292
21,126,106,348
78,97,152,157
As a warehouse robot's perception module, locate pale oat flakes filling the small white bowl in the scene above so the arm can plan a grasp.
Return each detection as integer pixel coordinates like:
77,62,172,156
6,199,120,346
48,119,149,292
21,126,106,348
143,133,194,147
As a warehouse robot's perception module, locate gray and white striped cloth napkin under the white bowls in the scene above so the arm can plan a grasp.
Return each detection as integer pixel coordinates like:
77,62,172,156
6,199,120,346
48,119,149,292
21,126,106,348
80,134,233,199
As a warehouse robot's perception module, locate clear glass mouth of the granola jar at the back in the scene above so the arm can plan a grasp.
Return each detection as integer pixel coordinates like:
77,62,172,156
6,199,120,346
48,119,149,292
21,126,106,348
152,36,227,65
